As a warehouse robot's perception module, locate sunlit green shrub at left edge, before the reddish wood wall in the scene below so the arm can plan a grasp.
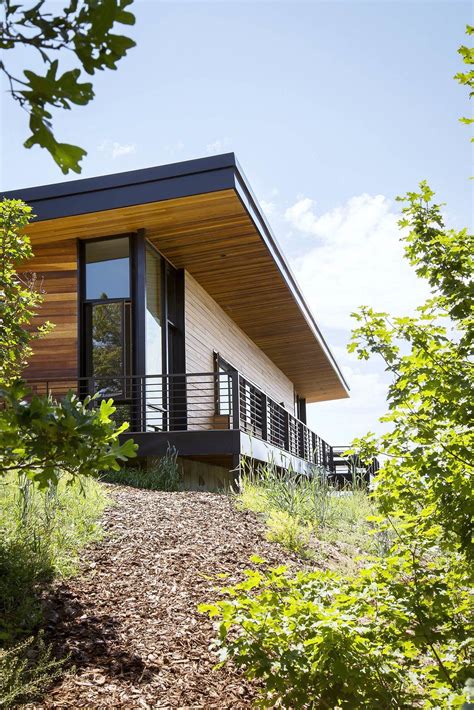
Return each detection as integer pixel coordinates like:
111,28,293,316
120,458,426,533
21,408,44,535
0,200,51,384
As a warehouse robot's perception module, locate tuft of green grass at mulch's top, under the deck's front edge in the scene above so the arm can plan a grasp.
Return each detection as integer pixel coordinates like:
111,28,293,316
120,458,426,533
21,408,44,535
104,447,183,491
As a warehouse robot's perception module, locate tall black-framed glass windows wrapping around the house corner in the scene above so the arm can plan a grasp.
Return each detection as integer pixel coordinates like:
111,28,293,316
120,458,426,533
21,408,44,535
81,234,186,431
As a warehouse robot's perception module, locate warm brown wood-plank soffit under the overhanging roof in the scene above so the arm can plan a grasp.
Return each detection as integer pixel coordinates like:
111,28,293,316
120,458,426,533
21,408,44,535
23,189,347,403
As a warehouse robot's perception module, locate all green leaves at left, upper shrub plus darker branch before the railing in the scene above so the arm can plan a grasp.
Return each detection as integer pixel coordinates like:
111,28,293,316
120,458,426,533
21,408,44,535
0,195,137,488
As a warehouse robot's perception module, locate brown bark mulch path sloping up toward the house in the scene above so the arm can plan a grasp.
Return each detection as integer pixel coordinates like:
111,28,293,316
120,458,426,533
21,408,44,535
30,487,302,709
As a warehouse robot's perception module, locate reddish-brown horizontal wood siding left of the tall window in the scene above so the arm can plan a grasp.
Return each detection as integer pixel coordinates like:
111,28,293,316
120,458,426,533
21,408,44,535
20,239,78,378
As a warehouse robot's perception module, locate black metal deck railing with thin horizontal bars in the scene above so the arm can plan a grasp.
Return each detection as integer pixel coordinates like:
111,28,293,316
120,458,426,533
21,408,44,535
23,371,378,477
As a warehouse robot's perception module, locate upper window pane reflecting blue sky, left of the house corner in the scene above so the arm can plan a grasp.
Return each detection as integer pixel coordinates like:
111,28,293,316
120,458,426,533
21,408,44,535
85,237,130,300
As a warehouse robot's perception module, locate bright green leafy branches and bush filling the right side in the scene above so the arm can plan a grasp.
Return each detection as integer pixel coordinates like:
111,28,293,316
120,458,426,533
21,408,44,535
203,183,474,710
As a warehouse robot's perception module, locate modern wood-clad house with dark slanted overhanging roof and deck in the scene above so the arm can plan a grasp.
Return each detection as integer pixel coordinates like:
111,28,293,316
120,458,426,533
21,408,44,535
5,153,374,485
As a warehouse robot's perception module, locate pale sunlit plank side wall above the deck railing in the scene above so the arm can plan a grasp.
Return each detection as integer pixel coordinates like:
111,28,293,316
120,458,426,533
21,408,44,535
184,272,294,412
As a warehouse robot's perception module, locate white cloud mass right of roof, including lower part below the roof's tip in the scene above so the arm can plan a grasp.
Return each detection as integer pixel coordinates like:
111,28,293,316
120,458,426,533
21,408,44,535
285,189,434,445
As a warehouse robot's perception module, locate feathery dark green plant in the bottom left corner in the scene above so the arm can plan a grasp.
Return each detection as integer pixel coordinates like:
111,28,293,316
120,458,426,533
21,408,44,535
0,632,64,708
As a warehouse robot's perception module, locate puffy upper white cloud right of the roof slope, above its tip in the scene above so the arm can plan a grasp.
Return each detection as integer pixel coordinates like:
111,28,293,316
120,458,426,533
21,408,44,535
285,194,427,330
